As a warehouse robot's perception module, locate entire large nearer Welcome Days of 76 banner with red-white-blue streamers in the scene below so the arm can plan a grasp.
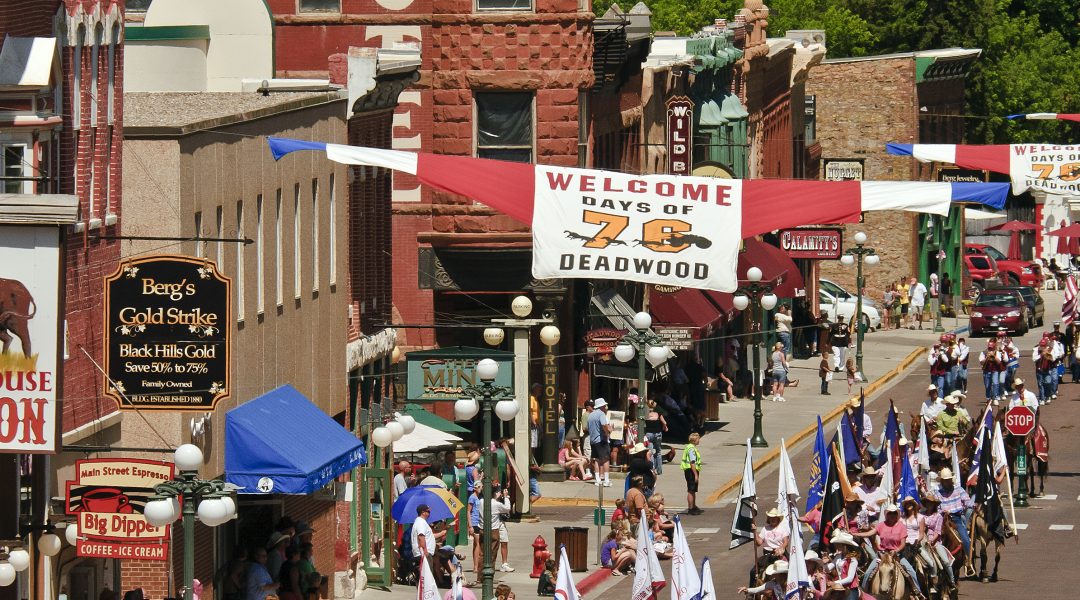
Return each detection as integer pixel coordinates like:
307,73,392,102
268,138,1008,291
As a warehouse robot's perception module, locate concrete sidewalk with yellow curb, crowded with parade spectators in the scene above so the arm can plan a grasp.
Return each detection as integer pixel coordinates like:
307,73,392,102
360,310,967,600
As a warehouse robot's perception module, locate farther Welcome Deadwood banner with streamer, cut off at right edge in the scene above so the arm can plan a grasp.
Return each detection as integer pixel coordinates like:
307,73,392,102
886,144,1080,195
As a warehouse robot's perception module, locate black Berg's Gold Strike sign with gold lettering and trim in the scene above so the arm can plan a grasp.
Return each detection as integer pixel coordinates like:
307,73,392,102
105,255,232,411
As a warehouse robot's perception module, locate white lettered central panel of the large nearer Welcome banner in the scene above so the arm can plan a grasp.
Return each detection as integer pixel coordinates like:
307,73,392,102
532,165,742,289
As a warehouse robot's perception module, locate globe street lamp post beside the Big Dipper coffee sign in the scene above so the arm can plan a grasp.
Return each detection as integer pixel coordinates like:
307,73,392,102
144,444,237,600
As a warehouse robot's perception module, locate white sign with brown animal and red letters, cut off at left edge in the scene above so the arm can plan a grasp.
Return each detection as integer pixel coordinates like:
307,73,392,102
0,226,60,453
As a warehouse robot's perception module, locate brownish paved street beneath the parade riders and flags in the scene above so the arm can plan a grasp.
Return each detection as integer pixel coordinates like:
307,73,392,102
599,295,1080,600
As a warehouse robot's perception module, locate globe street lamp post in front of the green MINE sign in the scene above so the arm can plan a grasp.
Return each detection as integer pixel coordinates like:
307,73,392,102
454,358,517,600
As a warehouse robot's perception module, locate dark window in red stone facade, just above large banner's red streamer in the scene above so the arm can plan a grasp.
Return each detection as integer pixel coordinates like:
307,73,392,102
476,92,532,163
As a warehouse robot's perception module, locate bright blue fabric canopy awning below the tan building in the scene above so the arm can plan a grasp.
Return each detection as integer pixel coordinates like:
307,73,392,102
225,385,367,494
